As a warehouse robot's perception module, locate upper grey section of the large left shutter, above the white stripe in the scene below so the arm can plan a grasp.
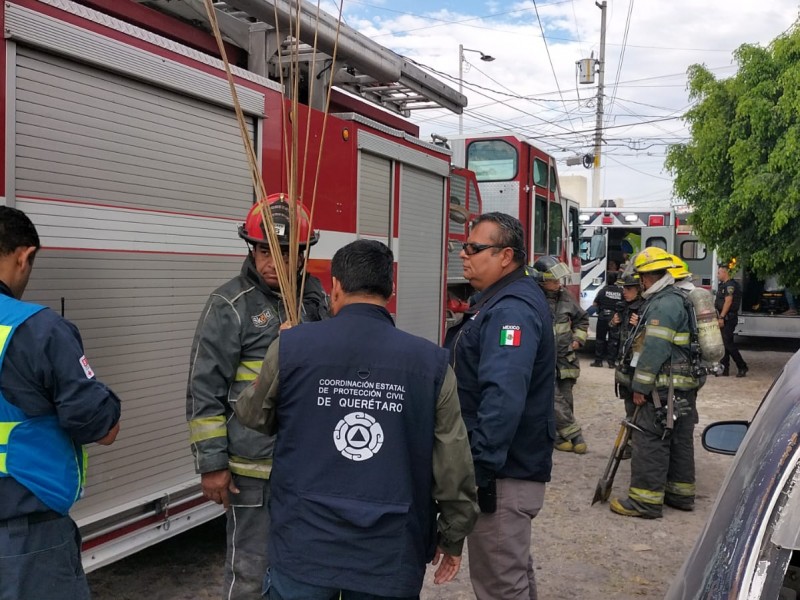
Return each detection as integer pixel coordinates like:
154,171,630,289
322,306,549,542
16,47,253,216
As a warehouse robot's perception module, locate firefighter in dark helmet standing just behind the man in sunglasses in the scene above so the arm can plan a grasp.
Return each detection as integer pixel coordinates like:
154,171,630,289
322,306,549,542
533,256,589,454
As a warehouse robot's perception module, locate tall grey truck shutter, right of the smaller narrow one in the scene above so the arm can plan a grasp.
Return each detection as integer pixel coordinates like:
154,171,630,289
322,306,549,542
396,165,445,343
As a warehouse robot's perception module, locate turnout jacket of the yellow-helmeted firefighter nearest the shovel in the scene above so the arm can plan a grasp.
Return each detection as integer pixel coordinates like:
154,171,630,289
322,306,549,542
631,285,703,395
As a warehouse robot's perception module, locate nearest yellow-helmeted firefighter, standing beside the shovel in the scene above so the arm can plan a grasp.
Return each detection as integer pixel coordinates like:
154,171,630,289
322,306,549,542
610,247,705,519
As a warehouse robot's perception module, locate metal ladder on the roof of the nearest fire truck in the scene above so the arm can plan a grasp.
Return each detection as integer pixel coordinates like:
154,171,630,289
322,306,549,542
136,0,467,117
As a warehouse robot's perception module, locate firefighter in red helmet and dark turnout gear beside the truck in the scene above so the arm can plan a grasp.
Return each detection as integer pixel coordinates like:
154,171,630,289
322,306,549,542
186,194,328,600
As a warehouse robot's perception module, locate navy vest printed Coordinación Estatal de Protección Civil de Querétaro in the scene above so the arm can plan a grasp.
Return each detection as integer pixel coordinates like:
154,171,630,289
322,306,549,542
269,304,448,597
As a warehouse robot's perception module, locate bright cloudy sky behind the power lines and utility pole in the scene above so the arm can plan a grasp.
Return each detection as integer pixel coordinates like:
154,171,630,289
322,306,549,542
324,0,798,207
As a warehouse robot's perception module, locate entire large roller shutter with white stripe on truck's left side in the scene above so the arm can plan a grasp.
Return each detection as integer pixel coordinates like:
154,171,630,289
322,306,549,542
14,45,253,536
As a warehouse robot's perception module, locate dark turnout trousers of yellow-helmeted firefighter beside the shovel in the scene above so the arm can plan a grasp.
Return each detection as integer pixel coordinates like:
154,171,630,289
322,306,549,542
628,390,697,517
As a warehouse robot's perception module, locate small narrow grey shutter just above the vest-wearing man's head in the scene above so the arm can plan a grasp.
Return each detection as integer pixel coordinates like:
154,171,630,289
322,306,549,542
358,152,392,246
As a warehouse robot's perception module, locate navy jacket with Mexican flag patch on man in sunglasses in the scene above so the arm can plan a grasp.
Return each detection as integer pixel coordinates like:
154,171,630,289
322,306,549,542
445,268,556,486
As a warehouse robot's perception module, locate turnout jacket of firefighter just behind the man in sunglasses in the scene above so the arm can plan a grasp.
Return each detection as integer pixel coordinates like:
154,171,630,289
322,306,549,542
546,287,589,379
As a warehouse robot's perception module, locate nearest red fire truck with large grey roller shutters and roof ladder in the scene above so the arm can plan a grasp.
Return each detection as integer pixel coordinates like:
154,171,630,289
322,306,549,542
0,0,482,570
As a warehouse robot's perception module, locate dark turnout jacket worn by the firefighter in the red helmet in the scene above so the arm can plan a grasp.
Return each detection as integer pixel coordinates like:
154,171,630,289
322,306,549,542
186,255,327,479
